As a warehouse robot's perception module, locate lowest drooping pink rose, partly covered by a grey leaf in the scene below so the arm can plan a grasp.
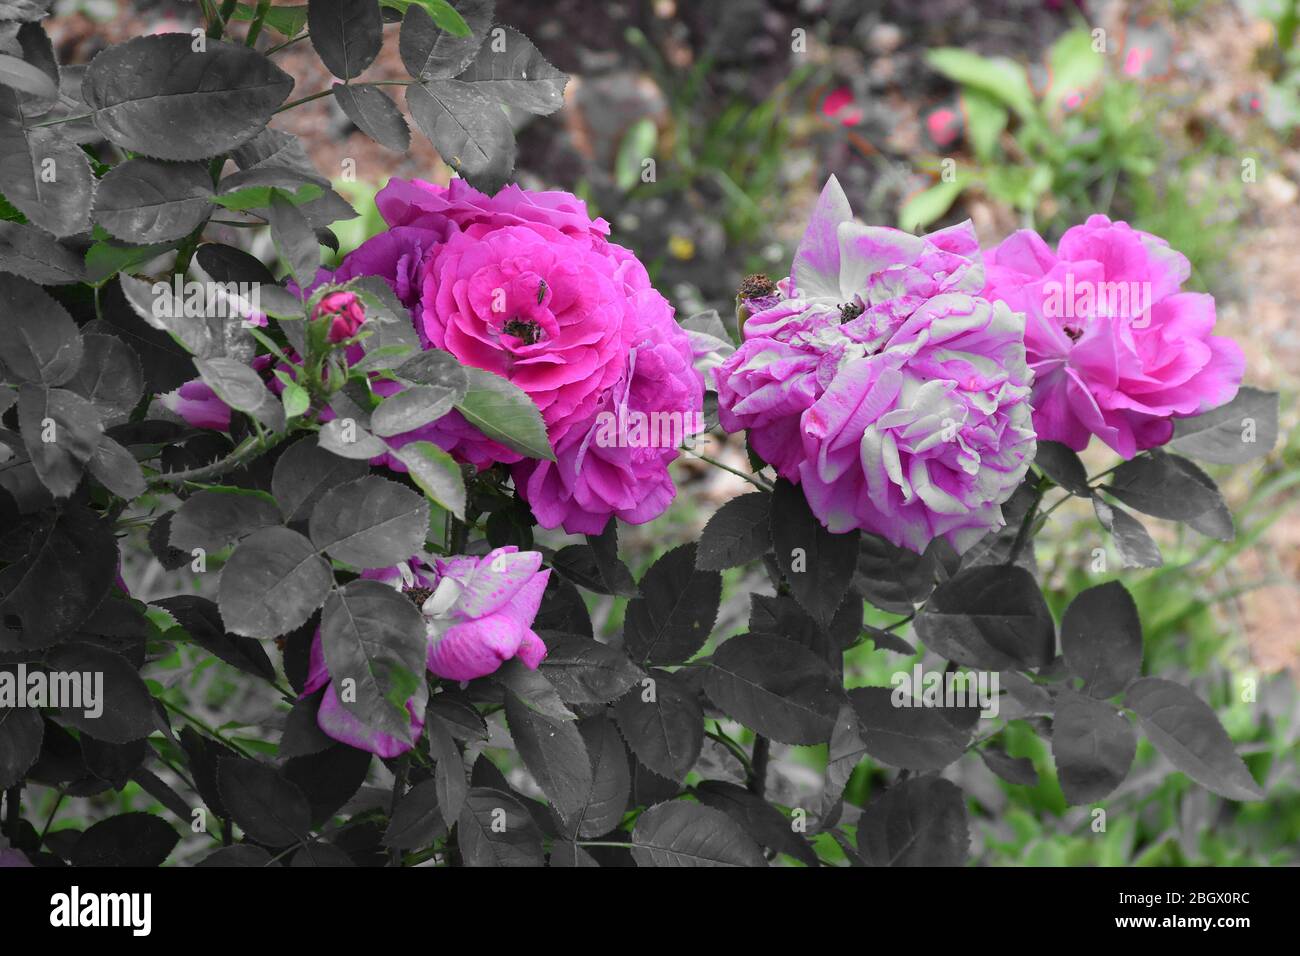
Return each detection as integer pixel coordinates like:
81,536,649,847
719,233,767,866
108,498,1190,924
303,546,551,757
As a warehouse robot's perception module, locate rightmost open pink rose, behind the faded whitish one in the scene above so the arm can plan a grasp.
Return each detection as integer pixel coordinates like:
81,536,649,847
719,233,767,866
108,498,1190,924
984,216,1244,458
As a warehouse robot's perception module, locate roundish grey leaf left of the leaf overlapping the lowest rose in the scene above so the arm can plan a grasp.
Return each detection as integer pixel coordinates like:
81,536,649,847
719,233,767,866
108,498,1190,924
217,528,334,637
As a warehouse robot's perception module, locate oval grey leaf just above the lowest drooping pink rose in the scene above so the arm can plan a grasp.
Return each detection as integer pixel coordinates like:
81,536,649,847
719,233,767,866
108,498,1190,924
309,475,429,568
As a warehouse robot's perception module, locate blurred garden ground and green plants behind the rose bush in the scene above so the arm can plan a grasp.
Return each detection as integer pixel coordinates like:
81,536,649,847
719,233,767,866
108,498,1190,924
32,0,1300,865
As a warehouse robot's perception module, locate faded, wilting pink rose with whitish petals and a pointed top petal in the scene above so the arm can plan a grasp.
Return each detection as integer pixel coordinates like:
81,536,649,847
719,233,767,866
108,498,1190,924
714,178,1035,551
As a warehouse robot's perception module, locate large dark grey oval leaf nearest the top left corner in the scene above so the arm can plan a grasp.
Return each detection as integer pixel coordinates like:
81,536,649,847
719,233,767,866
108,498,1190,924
83,33,294,161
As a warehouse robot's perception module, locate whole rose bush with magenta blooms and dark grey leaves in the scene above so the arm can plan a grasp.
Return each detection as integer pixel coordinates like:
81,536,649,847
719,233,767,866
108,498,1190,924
0,0,1277,868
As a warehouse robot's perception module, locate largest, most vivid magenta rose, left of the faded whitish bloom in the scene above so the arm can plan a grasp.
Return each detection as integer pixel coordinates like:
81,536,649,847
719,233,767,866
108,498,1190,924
319,179,703,532
